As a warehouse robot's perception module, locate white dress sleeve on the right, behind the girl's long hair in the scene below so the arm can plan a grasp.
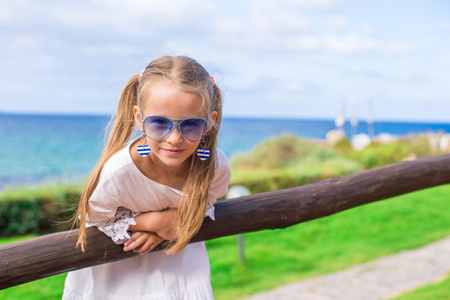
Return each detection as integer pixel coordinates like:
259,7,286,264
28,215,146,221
206,149,231,220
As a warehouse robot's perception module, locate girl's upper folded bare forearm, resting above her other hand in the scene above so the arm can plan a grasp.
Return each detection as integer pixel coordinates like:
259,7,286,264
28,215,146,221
128,208,177,241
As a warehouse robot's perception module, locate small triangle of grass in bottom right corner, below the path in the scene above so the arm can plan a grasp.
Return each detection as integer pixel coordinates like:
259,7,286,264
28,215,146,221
391,274,450,300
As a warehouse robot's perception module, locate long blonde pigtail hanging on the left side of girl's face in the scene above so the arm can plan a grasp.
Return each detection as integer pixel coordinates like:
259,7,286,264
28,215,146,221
73,75,139,252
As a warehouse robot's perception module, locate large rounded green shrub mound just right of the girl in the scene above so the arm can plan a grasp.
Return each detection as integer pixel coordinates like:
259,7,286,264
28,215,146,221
230,134,362,193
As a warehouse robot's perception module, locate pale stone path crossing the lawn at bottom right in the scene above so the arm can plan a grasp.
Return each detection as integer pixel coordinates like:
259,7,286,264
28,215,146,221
245,237,450,300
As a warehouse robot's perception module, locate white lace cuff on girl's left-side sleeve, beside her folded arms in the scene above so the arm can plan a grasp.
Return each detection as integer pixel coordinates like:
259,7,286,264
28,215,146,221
98,206,140,244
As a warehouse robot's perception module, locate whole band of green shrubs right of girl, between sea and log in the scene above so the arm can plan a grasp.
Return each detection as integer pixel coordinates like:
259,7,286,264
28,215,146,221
230,134,437,193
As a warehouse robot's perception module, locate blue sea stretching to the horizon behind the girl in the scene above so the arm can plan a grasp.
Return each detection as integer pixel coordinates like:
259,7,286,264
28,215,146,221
0,115,450,190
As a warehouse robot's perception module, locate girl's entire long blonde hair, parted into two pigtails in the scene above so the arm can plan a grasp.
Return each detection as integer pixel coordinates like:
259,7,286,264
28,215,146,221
75,56,222,254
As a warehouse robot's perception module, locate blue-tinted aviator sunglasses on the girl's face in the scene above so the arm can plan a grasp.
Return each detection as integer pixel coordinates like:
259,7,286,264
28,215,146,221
141,115,209,142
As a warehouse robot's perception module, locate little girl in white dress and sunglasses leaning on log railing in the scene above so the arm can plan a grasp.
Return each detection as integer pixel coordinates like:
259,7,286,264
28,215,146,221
63,57,230,300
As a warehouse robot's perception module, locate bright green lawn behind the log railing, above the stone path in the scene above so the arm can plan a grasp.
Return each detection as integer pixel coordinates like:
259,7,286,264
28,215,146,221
0,185,450,300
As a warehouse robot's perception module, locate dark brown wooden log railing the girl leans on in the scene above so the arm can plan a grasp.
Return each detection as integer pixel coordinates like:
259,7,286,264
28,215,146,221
0,154,450,289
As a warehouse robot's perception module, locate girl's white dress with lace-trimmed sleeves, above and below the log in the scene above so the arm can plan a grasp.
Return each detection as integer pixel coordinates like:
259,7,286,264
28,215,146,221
63,147,231,300
